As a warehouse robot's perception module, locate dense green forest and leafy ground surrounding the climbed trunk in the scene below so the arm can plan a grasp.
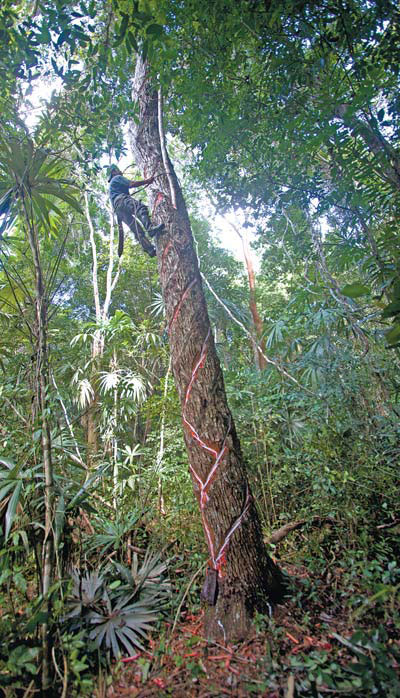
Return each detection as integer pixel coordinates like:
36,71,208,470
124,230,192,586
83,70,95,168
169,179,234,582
0,0,400,698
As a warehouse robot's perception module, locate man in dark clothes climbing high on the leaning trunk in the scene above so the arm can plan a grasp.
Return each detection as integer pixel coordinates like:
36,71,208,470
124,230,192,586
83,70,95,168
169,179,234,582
108,165,164,257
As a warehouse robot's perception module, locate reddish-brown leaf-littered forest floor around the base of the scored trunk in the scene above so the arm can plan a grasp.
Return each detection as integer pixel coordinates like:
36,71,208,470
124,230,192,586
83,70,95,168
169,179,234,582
105,565,400,698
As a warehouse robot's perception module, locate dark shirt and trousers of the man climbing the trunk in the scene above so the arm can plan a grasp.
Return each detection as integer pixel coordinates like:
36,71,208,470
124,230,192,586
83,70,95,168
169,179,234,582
110,189,156,257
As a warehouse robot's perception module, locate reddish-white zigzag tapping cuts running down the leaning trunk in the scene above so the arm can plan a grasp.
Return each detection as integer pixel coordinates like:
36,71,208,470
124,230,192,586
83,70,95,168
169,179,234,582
161,241,251,578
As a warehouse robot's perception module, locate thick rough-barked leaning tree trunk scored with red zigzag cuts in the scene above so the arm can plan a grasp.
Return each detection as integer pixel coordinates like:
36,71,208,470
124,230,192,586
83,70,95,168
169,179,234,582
131,59,282,641
